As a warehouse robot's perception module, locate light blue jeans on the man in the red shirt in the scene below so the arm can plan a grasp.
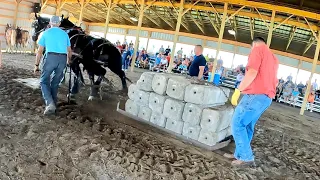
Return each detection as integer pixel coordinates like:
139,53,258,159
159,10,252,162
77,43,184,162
231,94,272,161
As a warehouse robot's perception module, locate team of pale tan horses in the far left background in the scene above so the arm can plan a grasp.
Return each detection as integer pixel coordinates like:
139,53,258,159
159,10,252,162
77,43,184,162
5,24,29,53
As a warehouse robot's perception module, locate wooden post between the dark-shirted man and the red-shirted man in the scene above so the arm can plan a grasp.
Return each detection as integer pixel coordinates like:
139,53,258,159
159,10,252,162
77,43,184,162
210,3,228,82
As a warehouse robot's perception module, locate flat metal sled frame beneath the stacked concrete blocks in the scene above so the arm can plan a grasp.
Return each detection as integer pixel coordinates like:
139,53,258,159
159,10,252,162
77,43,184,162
117,101,231,151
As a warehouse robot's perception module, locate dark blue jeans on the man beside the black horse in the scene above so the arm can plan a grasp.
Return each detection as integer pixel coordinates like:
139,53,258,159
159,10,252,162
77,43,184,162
40,54,67,106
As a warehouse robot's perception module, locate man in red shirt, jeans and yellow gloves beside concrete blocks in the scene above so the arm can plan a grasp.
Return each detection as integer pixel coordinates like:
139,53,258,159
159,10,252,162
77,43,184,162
224,37,279,167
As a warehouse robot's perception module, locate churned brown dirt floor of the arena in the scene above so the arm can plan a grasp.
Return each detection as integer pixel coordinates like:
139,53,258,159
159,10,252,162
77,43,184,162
0,54,320,180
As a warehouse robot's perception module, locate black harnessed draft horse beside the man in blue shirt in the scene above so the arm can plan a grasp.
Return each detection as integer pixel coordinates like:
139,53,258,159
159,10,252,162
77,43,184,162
33,16,129,100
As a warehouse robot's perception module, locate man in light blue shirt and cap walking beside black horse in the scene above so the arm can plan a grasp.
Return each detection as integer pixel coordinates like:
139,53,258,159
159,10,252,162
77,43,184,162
34,16,72,115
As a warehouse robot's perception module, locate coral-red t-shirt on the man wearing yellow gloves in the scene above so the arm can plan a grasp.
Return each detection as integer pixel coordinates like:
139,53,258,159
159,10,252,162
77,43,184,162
243,45,279,98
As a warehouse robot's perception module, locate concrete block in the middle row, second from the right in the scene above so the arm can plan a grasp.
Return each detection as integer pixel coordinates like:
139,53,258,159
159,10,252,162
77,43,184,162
182,103,203,125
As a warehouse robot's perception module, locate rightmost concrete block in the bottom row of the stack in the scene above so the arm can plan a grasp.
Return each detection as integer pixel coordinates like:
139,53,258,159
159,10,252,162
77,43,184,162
198,129,227,146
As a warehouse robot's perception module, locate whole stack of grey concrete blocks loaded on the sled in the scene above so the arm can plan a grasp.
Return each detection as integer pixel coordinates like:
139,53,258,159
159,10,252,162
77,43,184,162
125,72,234,146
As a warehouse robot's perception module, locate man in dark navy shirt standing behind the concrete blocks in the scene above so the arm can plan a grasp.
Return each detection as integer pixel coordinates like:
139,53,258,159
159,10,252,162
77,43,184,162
189,45,206,80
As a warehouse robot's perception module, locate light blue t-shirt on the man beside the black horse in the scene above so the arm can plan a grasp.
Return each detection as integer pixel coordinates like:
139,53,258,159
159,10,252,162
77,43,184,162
38,27,70,54
